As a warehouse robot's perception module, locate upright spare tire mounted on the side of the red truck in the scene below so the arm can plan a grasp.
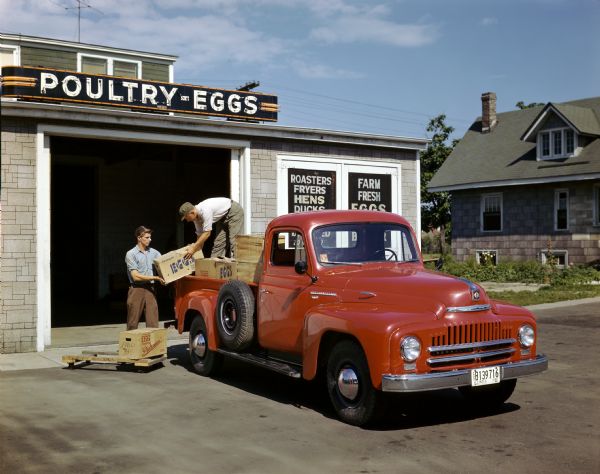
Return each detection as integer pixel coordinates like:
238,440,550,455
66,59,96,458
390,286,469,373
217,280,254,352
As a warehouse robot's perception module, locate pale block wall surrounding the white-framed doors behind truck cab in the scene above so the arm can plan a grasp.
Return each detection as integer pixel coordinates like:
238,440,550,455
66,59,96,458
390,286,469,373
250,140,418,233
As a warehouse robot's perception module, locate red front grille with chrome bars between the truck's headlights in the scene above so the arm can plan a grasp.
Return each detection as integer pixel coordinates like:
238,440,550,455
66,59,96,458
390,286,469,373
427,322,516,369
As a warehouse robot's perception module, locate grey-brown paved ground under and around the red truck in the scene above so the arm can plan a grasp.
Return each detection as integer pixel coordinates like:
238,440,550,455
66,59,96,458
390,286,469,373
0,298,600,474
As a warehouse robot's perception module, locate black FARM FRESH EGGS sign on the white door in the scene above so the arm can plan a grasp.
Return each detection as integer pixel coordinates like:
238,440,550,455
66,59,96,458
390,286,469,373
348,173,392,212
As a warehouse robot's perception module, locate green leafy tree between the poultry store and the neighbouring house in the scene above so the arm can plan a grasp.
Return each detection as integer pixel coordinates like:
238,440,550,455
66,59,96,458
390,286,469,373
421,114,458,254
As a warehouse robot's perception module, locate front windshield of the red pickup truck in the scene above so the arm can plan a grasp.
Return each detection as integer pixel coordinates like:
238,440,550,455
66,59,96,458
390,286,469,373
313,222,419,265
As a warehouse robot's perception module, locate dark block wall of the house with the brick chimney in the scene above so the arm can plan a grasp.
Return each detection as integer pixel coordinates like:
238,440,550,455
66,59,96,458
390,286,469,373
452,182,600,265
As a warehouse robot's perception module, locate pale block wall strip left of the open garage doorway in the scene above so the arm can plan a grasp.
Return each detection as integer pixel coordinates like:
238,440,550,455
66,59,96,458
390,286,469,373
0,117,37,353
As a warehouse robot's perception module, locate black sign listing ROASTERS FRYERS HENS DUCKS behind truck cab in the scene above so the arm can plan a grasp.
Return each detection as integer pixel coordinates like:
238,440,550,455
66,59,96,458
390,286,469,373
288,168,336,213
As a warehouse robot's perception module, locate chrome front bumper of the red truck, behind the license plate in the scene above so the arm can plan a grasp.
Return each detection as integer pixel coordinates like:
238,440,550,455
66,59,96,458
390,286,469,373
381,355,548,392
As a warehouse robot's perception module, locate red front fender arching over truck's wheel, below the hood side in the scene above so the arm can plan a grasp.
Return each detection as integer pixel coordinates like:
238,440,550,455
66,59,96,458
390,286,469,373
302,306,391,389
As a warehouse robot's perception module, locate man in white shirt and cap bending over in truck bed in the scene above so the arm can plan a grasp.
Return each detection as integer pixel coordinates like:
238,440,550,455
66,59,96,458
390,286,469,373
179,198,244,258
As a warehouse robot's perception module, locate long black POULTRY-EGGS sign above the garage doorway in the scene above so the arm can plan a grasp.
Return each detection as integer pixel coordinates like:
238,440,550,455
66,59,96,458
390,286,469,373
1,66,278,122
